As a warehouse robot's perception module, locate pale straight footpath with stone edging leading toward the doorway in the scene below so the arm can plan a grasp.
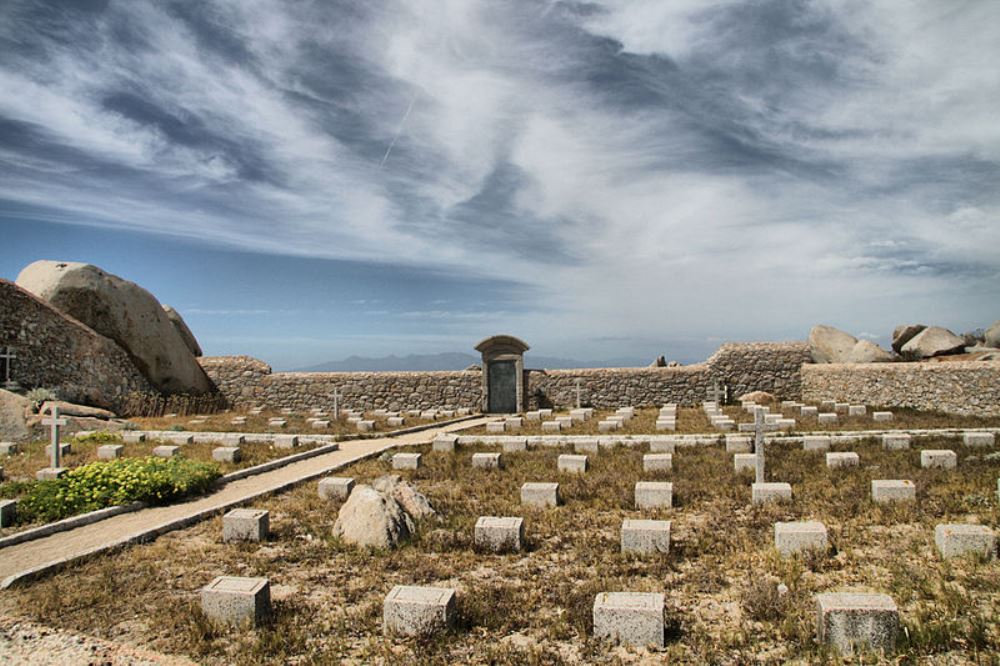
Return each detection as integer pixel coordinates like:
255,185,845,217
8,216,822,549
0,418,489,588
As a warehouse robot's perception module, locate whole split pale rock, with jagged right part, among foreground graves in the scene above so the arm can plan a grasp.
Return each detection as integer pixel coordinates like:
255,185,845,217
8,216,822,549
333,475,436,548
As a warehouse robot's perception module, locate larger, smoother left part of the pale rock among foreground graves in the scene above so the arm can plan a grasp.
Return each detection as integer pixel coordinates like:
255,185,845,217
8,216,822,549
333,485,415,548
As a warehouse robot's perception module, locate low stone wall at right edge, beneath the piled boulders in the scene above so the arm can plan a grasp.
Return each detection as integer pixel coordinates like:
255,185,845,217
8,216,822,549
802,361,1000,416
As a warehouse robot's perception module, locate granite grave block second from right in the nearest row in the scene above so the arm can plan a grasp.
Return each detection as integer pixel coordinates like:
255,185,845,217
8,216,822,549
594,592,664,648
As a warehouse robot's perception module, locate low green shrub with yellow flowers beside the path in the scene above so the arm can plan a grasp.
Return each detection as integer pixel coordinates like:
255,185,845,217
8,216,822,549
17,457,220,523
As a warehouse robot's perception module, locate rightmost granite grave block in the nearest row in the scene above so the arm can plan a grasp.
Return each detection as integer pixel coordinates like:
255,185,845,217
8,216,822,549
816,592,899,655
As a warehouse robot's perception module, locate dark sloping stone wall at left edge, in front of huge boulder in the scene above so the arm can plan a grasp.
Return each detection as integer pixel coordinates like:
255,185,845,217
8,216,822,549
0,280,153,410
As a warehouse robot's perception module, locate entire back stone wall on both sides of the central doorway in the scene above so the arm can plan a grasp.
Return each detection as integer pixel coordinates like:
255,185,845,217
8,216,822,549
200,343,809,410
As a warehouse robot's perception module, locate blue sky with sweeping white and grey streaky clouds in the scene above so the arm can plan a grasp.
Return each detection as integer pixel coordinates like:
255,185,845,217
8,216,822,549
0,0,1000,369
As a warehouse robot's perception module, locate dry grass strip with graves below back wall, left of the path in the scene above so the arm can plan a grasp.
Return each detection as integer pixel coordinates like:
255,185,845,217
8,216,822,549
131,411,432,435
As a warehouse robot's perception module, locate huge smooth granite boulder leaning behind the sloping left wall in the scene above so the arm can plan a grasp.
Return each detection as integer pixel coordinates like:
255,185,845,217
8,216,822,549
17,261,214,394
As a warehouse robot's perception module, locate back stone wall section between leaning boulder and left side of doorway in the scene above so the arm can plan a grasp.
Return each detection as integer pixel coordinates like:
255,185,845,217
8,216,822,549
199,356,482,411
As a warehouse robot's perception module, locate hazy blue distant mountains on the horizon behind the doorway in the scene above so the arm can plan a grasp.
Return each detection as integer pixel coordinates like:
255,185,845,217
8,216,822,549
289,352,653,372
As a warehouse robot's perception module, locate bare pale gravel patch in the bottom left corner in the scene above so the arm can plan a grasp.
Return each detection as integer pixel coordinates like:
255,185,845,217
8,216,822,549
0,617,194,666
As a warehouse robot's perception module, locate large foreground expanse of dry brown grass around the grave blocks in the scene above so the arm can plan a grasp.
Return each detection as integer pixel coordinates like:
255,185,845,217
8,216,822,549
0,430,1000,664
